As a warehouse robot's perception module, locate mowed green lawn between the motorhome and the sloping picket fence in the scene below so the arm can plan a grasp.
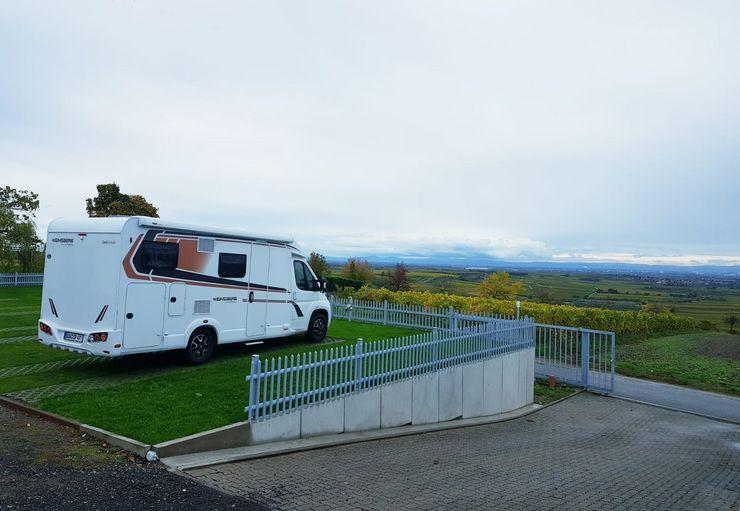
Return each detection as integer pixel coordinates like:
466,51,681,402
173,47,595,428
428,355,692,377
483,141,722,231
37,320,421,443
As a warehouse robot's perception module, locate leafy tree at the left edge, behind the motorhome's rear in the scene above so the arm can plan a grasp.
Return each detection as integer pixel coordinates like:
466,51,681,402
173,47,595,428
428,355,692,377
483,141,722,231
0,186,43,272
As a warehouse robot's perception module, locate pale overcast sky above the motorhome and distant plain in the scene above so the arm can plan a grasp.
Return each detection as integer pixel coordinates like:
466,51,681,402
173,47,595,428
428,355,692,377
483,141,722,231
0,0,740,264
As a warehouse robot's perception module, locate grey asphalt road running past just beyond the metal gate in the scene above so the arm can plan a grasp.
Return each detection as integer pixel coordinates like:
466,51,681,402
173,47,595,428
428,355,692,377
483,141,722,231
535,363,740,424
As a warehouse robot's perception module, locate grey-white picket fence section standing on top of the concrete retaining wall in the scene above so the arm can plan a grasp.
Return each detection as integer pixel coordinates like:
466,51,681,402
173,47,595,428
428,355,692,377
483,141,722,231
245,318,535,422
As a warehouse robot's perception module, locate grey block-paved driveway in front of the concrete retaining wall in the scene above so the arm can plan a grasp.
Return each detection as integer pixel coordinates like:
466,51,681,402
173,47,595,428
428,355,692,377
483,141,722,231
191,394,740,511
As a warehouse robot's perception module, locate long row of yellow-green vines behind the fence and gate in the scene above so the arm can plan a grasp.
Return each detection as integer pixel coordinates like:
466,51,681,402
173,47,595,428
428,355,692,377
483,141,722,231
354,287,699,336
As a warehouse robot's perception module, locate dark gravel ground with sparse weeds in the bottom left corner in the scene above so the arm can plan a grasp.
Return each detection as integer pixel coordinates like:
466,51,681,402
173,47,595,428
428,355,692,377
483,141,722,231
0,406,264,511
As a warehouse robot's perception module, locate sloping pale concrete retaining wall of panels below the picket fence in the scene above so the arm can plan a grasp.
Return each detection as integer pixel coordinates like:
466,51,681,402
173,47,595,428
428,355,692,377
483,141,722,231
248,349,534,444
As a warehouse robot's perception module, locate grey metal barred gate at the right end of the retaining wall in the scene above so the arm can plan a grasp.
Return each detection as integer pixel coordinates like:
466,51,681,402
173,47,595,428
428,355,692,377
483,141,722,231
534,323,616,392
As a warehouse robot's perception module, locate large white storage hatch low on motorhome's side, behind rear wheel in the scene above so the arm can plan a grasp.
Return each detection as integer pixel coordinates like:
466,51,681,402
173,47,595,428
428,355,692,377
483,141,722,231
123,282,165,349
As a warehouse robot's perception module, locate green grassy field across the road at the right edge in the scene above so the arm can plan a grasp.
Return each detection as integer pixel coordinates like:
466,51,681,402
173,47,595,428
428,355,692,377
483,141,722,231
617,332,740,396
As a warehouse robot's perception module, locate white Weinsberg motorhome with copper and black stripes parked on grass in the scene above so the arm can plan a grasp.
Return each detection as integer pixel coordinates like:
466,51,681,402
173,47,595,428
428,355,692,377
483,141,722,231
38,217,331,364
